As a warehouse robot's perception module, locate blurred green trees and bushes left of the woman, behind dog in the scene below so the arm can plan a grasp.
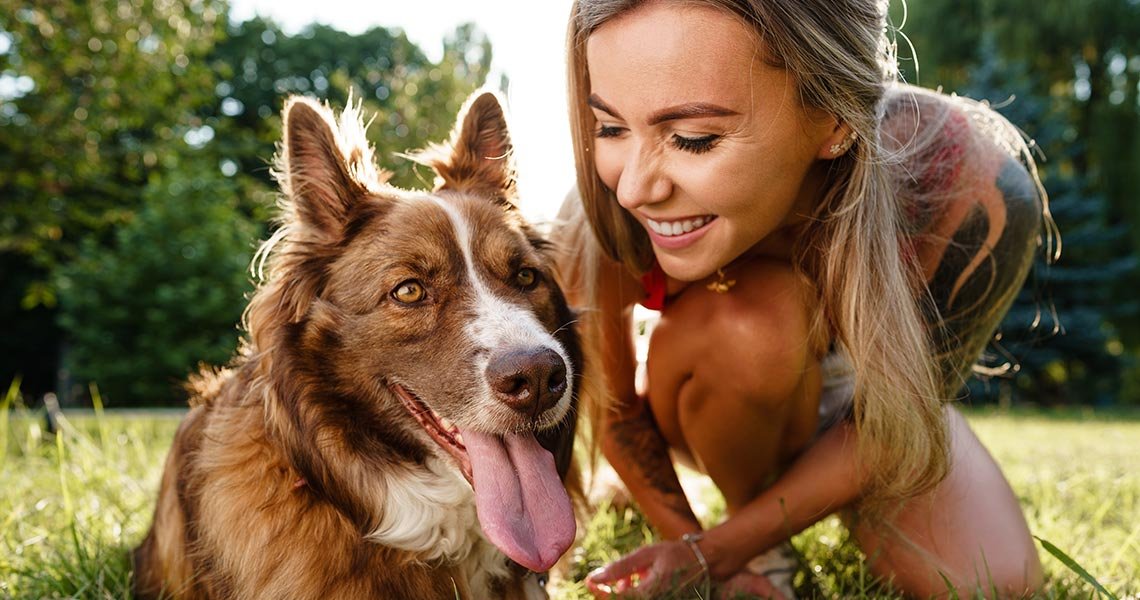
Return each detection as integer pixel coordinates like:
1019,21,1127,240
0,0,491,406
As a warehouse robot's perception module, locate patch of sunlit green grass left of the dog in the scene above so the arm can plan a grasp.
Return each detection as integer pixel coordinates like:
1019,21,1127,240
0,410,178,599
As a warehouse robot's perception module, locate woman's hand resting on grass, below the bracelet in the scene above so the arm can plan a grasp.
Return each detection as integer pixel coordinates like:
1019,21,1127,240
586,541,709,598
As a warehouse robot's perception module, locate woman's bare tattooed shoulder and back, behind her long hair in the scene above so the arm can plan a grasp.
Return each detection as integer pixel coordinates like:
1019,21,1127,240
882,87,1049,381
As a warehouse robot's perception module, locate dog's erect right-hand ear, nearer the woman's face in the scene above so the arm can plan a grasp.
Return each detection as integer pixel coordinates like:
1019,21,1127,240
413,91,516,203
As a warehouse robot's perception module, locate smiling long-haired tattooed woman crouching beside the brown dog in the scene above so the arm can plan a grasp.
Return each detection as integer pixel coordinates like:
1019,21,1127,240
559,0,1049,598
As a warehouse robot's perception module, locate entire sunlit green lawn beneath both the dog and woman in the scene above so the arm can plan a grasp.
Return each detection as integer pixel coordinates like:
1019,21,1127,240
0,401,1140,599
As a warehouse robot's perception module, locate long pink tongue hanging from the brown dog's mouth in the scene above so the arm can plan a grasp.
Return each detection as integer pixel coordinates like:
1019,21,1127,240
462,431,576,571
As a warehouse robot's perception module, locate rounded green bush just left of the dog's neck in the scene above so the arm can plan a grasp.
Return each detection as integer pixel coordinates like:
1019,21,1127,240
58,164,257,406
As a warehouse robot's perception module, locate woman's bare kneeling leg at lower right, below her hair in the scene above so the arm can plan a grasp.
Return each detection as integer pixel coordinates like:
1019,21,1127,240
852,408,1042,598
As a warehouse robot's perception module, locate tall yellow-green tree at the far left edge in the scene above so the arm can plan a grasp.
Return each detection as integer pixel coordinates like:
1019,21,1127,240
0,0,225,401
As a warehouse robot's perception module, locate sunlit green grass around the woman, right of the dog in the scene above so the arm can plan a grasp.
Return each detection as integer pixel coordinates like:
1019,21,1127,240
554,410,1140,599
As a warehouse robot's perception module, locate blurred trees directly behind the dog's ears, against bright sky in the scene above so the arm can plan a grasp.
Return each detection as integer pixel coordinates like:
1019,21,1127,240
207,18,491,187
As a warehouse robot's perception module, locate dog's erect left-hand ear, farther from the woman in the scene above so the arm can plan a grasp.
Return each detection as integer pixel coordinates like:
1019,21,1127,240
276,96,365,236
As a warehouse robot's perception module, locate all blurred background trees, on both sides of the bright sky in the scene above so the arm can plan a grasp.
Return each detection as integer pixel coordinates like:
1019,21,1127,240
0,0,1140,406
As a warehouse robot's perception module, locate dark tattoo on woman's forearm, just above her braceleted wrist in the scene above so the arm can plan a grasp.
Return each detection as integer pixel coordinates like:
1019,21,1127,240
609,402,695,520
